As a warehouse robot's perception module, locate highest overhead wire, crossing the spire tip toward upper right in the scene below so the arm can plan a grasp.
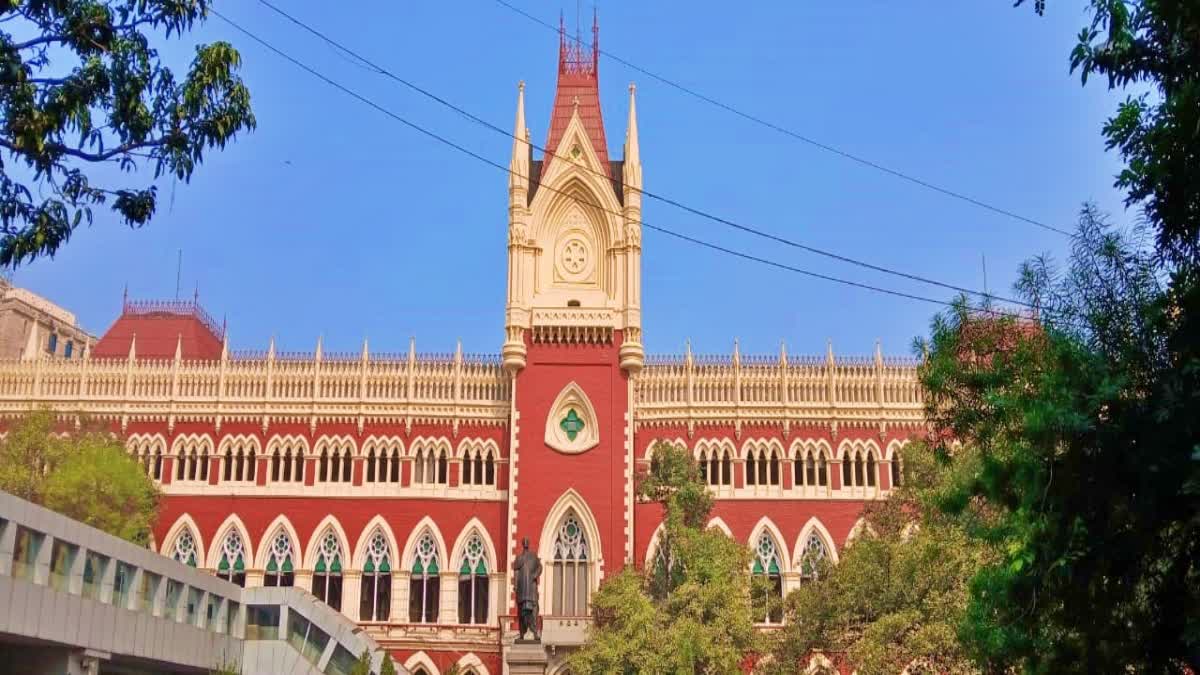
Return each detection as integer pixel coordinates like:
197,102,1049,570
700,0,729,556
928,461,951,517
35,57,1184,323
496,0,1075,238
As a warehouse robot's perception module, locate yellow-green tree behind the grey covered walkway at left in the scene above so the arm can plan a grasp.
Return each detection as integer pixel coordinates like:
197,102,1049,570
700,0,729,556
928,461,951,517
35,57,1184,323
0,403,160,544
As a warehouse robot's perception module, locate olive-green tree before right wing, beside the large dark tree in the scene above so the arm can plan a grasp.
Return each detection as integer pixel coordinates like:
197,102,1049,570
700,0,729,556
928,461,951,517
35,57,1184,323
766,442,994,675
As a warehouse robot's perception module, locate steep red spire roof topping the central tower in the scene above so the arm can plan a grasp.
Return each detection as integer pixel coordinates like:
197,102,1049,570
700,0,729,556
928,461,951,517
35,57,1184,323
546,20,612,179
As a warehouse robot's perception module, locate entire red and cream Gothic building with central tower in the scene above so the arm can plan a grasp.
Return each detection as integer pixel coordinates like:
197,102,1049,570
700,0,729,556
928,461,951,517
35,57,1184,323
0,21,923,675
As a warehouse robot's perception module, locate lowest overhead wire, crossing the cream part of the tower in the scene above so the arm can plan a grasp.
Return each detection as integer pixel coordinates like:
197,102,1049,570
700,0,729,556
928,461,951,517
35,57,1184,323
209,7,1036,317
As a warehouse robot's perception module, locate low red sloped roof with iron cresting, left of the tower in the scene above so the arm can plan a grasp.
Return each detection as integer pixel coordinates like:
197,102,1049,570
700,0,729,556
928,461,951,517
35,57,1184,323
91,300,224,360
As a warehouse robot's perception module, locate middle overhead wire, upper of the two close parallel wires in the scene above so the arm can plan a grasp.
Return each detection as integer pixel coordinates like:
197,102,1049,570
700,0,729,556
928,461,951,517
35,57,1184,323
241,0,1032,309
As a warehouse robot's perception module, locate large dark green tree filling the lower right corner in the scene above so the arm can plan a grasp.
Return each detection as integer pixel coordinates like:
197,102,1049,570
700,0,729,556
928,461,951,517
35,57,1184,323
920,207,1200,673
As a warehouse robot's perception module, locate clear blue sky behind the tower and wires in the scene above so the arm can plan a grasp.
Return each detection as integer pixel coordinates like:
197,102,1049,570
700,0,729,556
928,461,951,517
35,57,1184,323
14,0,1130,354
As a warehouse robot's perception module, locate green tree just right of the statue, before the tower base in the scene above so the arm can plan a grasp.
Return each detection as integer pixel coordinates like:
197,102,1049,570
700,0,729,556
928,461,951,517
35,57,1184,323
568,443,761,675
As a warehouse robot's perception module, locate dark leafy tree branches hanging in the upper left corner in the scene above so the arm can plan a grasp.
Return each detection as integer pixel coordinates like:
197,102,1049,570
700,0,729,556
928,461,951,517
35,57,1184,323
0,0,254,265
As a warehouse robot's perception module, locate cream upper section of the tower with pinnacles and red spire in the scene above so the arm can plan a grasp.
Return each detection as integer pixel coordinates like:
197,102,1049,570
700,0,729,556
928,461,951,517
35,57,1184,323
503,14,644,372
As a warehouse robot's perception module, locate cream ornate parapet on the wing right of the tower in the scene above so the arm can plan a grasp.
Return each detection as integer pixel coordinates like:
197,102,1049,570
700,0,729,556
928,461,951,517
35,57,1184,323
634,345,924,429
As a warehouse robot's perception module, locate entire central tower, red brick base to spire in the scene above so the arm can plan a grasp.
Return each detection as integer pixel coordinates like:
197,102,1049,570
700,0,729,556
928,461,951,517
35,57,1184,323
503,17,644,646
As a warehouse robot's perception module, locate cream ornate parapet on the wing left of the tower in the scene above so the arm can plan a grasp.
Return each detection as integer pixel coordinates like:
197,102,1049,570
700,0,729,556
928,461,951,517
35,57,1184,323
0,345,511,426
